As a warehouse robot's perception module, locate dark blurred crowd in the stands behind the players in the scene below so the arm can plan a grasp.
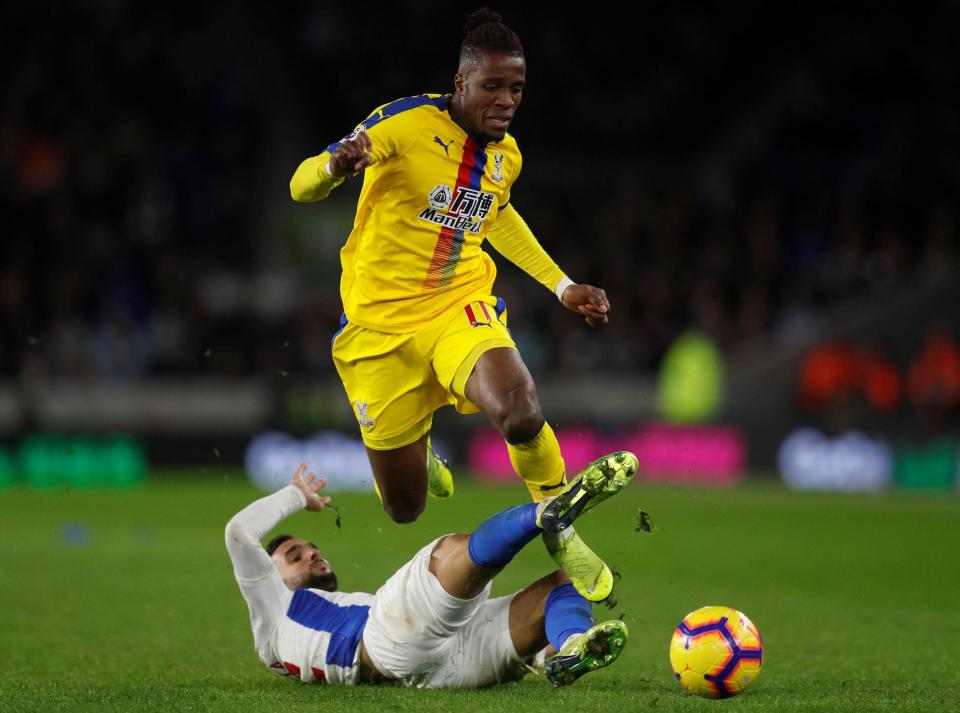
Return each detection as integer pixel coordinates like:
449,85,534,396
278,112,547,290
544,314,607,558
0,0,960,476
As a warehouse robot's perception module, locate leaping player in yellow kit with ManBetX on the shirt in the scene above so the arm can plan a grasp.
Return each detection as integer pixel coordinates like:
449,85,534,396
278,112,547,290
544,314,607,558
290,8,612,601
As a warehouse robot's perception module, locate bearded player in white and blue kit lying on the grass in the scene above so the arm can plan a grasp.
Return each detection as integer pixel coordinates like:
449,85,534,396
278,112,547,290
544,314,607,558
226,452,637,688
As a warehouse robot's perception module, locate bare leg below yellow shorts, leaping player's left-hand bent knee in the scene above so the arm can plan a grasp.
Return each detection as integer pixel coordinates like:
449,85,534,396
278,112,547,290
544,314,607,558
367,428,427,523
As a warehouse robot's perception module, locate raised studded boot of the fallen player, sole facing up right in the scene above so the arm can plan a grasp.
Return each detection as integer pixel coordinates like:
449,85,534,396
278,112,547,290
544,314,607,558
537,451,638,532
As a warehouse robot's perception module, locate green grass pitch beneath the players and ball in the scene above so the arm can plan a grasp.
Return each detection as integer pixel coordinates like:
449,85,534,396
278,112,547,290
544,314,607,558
0,473,960,713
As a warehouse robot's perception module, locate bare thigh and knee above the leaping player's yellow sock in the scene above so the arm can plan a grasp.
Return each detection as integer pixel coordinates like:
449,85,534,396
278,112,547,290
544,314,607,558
464,347,543,443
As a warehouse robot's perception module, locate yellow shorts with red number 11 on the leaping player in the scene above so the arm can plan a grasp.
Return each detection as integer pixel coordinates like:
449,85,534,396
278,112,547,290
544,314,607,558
332,296,516,451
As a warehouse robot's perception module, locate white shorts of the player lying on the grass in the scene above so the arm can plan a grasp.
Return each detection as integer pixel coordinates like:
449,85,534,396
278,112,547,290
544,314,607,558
363,538,529,688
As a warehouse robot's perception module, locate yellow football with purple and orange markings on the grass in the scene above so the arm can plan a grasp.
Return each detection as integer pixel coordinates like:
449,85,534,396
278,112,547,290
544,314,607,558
670,606,763,698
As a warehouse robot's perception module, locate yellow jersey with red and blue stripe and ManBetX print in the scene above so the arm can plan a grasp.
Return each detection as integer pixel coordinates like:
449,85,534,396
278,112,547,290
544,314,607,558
291,94,522,333
